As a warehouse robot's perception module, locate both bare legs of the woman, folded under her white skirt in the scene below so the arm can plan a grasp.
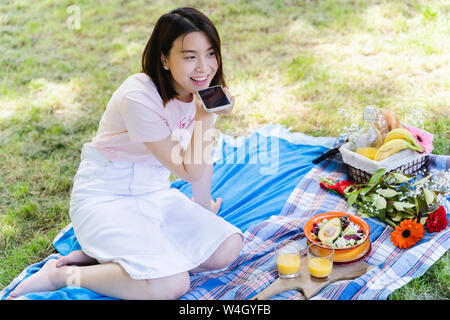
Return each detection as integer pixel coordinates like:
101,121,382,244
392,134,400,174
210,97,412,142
5,233,242,300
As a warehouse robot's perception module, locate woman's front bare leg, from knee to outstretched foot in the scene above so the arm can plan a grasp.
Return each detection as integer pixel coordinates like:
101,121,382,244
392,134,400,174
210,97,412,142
10,259,190,300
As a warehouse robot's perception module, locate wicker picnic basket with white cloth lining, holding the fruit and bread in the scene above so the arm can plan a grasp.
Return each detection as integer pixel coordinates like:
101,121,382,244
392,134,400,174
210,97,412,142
339,143,429,184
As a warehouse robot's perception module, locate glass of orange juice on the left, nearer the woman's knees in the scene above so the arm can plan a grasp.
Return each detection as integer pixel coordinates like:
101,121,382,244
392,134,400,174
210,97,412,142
275,241,301,278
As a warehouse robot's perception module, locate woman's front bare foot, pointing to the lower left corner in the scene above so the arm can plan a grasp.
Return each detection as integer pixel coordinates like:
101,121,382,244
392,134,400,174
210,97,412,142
6,259,65,300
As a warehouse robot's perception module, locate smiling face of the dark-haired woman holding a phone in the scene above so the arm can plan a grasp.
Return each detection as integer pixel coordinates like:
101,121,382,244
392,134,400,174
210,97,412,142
161,31,218,101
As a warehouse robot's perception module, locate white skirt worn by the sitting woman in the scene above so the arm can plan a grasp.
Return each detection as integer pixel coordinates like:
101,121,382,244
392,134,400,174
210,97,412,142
69,143,243,279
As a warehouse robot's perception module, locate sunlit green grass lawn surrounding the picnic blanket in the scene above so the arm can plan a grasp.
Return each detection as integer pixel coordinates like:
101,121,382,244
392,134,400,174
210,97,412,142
0,0,450,300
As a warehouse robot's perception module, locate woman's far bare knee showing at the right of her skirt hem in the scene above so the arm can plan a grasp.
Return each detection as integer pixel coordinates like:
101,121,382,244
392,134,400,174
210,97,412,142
190,233,243,273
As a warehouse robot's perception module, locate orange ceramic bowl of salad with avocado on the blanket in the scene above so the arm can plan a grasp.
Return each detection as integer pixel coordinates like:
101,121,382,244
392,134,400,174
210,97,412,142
303,212,371,263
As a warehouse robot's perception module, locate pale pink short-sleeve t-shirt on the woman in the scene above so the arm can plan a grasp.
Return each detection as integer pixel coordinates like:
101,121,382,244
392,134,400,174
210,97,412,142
92,73,196,165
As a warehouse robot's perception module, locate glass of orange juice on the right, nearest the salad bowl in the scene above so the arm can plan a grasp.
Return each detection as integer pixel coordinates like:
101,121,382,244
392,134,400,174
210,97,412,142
307,243,334,281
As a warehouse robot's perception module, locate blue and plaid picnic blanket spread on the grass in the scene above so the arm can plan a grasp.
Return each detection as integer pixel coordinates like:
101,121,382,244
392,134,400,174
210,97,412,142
0,125,450,300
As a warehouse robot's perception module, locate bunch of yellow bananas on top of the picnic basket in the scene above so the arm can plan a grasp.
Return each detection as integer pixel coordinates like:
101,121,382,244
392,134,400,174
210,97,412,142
374,128,424,161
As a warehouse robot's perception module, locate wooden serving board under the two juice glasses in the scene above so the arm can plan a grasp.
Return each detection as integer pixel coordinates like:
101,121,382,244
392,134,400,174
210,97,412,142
250,256,369,300
